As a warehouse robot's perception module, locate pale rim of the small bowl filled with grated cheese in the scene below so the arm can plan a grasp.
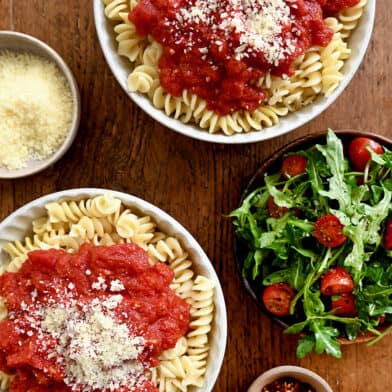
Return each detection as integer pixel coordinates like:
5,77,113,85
0,30,82,179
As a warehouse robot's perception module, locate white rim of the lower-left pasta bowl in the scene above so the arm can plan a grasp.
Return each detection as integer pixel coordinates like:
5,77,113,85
0,188,228,392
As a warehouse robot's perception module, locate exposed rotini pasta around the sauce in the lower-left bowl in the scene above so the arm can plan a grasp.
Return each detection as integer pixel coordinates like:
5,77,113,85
0,194,214,392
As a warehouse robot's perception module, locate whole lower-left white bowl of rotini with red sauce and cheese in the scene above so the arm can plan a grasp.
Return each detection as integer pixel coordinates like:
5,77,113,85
0,188,227,392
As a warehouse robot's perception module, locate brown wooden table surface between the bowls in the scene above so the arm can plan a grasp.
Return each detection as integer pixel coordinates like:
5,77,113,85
0,0,392,392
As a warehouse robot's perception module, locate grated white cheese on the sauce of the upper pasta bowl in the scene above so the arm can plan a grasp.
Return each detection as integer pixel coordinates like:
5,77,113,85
175,0,298,65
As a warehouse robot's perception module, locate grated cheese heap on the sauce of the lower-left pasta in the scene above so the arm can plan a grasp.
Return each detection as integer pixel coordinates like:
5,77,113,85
41,304,145,392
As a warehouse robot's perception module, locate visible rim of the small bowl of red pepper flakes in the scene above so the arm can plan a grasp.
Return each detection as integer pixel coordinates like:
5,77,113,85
248,366,333,392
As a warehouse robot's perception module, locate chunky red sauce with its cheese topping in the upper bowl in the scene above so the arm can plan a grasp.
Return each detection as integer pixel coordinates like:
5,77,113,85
129,0,359,115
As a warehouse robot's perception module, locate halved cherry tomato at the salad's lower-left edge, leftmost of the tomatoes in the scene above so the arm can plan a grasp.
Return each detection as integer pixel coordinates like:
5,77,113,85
263,283,295,316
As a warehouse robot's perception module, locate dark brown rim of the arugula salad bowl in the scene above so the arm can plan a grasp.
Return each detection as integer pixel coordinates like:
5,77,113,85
233,128,392,345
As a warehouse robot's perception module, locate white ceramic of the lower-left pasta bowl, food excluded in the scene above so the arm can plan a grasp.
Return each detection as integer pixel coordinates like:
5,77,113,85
0,188,227,392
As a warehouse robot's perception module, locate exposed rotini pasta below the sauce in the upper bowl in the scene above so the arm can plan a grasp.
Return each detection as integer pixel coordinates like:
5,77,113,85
104,0,367,136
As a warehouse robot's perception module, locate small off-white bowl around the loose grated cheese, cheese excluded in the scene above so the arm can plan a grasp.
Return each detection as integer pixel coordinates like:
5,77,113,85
0,31,81,178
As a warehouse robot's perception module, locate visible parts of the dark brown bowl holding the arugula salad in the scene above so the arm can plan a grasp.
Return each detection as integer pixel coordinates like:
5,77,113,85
234,129,392,344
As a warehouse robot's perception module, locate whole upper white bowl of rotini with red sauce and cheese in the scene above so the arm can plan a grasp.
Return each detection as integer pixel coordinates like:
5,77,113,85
94,0,375,144
